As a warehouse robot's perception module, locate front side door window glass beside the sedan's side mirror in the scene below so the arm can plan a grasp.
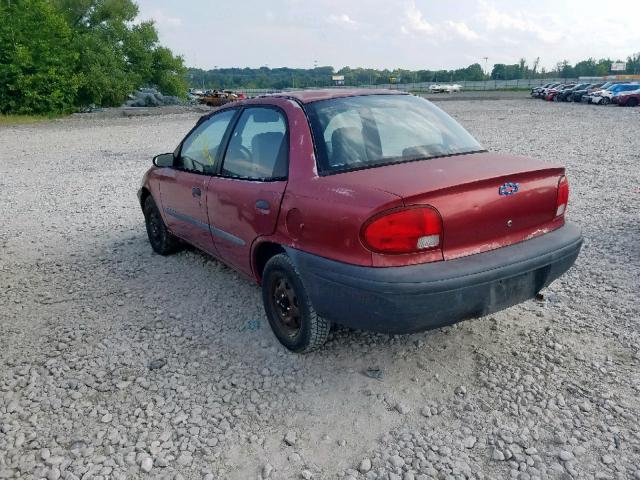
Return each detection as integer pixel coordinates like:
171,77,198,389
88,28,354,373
176,110,237,175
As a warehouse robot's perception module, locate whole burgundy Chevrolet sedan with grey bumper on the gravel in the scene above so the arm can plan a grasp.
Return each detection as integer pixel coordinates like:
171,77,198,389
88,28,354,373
138,90,582,352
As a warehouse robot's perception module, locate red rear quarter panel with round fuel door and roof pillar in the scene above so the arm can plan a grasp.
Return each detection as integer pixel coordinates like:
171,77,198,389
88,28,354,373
252,99,442,270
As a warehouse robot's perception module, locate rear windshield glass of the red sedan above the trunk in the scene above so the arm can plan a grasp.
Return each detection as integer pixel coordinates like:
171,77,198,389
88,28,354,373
305,94,484,174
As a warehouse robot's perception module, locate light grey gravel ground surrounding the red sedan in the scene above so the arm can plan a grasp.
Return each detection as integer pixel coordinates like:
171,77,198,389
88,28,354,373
0,99,640,480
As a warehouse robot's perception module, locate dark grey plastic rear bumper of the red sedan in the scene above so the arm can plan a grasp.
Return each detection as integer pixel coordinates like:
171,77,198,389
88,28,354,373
287,224,582,333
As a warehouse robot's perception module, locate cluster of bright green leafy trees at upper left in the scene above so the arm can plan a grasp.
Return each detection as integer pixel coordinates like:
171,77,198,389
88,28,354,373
0,0,187,114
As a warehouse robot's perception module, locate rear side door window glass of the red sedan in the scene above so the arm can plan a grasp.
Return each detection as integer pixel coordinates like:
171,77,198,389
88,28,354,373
222,107,289,180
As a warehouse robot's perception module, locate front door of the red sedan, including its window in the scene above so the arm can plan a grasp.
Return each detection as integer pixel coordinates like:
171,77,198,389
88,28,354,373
160,110,237,253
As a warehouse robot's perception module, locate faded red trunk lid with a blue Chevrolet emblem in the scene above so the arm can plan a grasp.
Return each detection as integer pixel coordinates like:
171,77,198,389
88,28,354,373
338,152,564,259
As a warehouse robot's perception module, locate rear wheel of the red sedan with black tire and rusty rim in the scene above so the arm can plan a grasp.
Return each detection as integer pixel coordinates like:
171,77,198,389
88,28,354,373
262,253,331,353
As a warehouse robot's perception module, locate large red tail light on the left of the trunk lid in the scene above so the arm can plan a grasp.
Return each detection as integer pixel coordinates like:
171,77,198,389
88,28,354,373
361,207,442,254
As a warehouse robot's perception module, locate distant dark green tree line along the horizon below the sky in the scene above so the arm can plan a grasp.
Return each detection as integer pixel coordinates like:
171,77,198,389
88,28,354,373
186,53,640,90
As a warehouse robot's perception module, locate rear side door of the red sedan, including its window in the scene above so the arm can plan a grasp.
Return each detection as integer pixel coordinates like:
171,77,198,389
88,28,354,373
207,106,289,275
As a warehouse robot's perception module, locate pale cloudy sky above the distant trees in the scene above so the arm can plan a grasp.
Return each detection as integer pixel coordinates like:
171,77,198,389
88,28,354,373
137,0,640,70
